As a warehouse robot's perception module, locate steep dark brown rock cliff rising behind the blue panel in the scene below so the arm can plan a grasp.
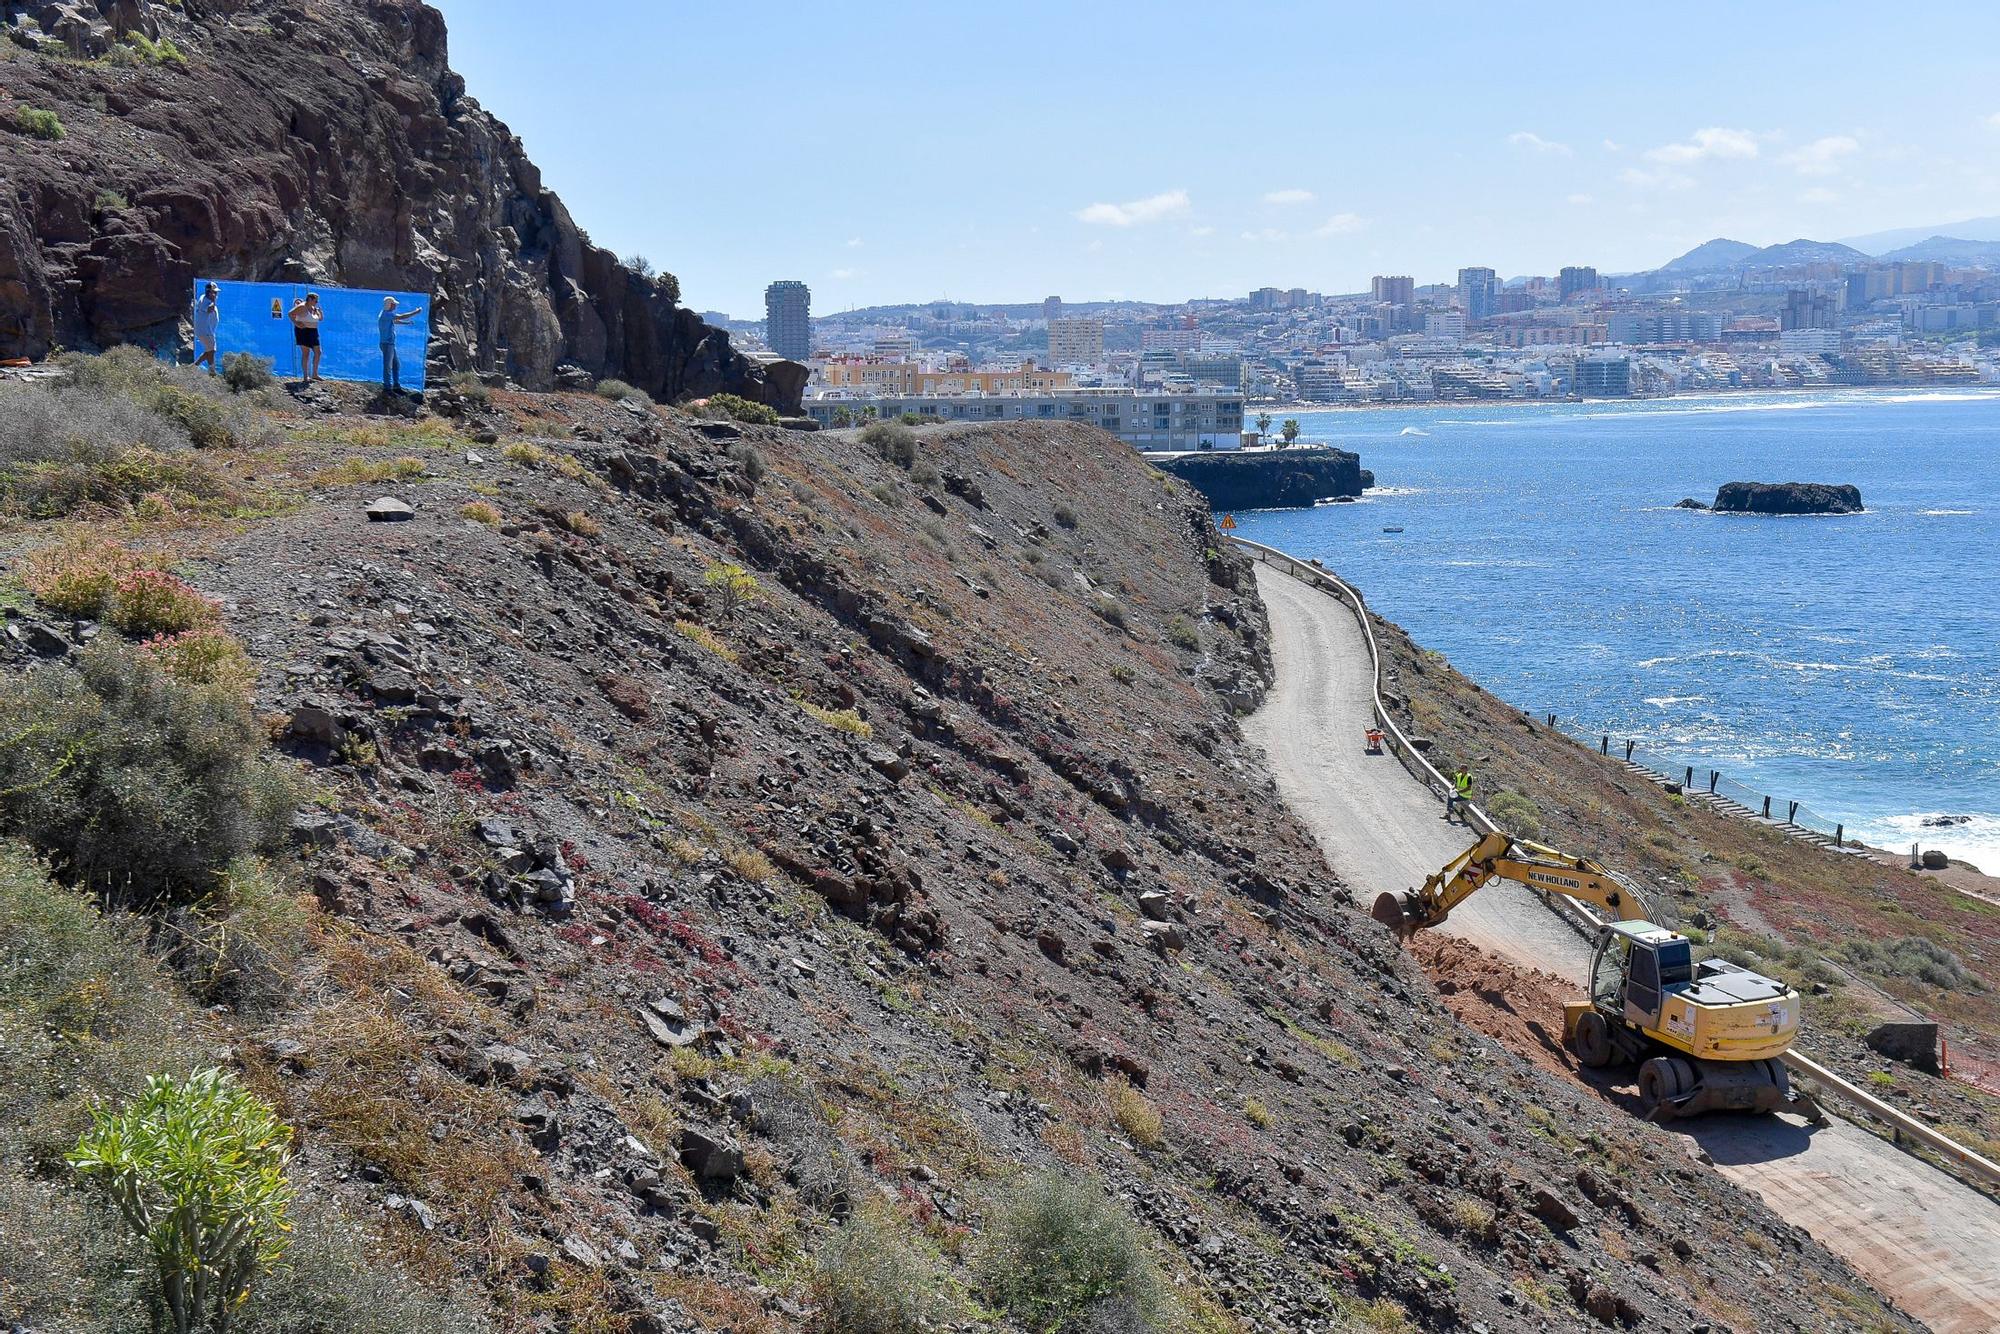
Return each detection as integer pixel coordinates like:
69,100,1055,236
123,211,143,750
0,0,804,410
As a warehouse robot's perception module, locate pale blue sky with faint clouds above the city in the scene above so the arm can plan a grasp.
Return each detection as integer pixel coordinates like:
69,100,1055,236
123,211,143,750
438,0,2000,316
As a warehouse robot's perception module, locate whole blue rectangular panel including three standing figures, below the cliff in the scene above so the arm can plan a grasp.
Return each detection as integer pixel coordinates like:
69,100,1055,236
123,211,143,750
190,278,430,394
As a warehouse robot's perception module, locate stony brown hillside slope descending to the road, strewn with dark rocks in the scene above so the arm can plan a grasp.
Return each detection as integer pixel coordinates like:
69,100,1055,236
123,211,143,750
0,358,1908,1334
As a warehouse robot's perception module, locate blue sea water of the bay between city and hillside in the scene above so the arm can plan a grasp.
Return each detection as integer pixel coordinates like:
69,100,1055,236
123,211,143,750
1238,390,2000,874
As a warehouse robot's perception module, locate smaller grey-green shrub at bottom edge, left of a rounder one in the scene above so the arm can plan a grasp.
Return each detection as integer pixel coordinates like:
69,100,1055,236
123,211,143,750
812,1208,962,1334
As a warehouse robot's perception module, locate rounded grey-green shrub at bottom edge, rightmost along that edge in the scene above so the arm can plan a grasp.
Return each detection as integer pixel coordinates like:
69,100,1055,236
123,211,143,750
980,1172,1164,1334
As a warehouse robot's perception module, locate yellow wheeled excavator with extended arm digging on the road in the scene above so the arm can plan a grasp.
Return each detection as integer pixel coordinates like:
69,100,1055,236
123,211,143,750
1372,832,1800,1120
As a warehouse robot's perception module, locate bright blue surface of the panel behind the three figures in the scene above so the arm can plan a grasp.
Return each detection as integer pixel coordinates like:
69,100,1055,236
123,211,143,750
188,278,430,392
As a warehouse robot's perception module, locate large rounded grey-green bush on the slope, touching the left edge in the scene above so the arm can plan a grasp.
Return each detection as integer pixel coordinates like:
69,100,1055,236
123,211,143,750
0,640,294,904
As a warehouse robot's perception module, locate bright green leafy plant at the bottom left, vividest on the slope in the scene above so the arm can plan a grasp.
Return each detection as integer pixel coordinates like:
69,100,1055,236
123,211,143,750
70,1070,292,1334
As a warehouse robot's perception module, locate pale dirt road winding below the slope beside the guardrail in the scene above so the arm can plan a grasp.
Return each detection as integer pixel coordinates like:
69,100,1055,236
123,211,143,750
1244,566,2000,1334
